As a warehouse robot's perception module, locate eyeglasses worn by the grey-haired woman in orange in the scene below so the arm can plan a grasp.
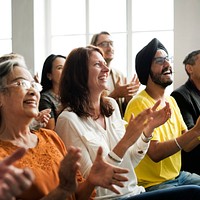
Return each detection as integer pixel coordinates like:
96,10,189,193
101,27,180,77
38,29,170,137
4,80,42,92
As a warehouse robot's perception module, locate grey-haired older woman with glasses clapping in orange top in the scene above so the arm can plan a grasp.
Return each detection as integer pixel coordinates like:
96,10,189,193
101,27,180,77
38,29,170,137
0,59,131,200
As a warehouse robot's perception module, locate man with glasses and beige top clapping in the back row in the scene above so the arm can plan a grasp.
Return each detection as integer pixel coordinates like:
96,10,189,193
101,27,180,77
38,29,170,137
91,32,140,117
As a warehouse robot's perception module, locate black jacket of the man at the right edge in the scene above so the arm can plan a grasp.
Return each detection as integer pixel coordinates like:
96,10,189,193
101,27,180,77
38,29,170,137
171,80,200,175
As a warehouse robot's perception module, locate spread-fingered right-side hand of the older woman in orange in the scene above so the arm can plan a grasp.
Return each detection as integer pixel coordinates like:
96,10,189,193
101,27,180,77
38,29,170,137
88,147,128,194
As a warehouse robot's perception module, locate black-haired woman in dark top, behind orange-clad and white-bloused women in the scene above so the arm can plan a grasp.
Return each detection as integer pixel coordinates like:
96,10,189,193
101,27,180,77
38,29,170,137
39,54,66,130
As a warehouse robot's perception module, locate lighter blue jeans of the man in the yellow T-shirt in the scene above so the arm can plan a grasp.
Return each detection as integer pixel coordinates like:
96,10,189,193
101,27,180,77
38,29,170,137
145,171,200,191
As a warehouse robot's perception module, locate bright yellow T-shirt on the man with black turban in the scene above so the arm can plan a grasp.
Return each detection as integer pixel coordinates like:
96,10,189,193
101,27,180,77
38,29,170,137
124,90,186,188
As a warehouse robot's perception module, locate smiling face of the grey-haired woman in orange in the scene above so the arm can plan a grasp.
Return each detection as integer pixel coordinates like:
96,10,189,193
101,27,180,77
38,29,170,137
0,66,40,119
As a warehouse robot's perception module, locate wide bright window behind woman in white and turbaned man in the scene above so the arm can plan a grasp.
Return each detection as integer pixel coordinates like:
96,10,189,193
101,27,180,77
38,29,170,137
49,0,174,82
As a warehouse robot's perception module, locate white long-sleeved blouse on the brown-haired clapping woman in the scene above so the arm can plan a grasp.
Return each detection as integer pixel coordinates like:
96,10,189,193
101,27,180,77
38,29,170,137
55,97,149,199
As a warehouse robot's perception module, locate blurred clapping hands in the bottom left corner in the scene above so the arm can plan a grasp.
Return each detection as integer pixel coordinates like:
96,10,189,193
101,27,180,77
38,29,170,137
0,148,34,200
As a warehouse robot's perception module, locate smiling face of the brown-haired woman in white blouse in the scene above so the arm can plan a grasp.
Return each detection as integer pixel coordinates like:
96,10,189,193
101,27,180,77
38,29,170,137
88,51,109,93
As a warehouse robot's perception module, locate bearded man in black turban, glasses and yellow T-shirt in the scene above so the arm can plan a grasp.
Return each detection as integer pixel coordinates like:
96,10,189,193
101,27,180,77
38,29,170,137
124,38,200,191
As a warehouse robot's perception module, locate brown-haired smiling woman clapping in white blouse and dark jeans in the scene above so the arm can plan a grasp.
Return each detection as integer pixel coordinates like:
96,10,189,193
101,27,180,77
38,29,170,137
55,46,200,200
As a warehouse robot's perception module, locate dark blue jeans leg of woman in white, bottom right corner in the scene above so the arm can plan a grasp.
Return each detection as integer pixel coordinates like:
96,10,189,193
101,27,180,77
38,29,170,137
124,185,200,200
